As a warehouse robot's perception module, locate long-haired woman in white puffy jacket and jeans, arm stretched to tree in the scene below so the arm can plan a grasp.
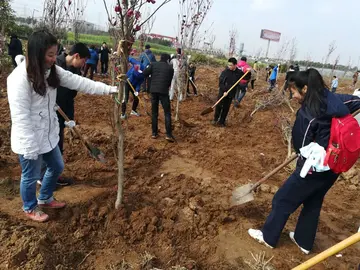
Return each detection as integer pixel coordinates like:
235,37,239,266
7,31,117,222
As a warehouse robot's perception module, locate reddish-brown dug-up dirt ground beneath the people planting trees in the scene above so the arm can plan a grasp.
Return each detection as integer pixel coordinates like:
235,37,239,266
0,67,360,270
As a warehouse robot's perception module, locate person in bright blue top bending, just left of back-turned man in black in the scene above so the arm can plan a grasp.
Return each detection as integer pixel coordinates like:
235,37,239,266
121,57,144,119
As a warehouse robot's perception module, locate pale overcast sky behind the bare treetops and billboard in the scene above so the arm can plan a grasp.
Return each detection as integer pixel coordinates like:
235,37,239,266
12,0,360,65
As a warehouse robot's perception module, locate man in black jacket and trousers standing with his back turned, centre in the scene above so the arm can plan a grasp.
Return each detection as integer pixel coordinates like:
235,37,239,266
144,54,175,142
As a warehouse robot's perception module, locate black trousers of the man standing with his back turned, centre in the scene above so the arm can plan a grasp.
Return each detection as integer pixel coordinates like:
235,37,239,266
151,93,172,137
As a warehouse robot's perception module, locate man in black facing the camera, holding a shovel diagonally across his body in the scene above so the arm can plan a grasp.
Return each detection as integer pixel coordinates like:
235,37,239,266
212,58,244,127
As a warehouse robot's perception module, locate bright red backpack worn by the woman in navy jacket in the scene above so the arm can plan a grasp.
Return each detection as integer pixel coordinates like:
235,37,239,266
324,114,360,174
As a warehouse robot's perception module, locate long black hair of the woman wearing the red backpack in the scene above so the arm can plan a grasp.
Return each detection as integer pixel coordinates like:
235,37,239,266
289,68,328,117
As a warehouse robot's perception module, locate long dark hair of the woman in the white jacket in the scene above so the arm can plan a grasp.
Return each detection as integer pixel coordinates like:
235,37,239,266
26,30,60,96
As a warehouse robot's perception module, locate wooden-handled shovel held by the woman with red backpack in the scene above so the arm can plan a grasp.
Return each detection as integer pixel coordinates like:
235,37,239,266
231,154,298,206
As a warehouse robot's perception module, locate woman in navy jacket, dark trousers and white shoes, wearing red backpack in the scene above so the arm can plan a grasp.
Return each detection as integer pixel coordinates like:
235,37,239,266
248,69,360,254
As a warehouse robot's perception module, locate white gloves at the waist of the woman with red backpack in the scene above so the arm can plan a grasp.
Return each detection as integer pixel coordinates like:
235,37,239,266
300,142,330,178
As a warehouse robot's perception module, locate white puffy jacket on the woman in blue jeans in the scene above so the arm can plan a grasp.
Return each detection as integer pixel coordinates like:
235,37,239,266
7,61,111,155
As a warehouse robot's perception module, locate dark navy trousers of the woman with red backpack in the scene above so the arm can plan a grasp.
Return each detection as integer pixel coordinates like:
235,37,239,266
262,169,338,250
